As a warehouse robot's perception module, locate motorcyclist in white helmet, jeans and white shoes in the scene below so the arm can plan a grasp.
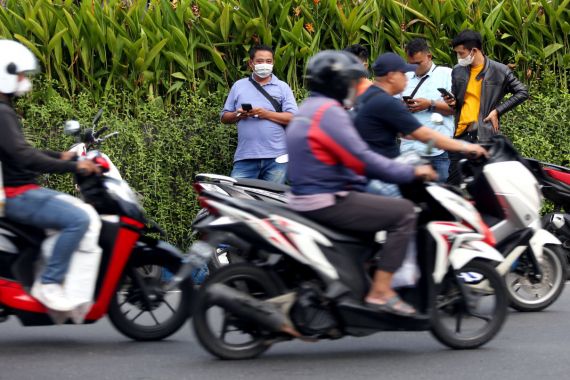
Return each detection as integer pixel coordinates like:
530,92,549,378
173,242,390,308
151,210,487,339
0,40,100,311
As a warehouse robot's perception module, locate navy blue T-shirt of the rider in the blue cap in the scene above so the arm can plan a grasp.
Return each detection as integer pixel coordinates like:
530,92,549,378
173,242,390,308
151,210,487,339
354,85,422,158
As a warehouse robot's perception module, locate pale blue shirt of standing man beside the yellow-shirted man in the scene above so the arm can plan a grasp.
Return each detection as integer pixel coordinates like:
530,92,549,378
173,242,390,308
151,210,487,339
400,64,454,156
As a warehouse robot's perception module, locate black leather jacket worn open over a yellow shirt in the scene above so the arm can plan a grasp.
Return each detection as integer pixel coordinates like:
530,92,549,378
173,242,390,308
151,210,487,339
451,57,528,141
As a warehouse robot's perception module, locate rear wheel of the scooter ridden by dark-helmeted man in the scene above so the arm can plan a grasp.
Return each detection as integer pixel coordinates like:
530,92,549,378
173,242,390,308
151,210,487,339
192,263,280,360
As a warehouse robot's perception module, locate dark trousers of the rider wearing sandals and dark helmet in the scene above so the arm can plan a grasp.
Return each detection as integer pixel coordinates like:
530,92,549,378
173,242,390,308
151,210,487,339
302,192,416,273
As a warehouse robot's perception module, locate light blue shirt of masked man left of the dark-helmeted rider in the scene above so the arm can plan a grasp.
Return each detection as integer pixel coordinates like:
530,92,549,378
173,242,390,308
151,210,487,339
220,75,297,162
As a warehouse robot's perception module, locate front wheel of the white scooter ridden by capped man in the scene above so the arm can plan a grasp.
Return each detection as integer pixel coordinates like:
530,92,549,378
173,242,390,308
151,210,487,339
505,245,567,311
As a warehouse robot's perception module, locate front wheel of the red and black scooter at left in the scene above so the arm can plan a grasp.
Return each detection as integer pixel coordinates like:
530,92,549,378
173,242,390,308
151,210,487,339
108,249,194,341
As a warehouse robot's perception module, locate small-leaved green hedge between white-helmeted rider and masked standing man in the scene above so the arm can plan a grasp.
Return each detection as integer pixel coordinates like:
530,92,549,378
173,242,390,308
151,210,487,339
17,80,233,247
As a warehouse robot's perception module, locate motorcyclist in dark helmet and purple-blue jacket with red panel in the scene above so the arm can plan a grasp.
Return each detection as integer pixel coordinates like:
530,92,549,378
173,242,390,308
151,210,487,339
287,51,437,316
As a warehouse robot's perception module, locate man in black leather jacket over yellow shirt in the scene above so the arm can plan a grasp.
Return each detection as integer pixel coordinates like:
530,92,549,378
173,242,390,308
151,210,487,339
444,29,528,184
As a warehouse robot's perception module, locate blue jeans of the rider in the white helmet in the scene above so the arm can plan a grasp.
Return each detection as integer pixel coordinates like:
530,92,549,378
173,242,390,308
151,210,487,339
6,188,90,284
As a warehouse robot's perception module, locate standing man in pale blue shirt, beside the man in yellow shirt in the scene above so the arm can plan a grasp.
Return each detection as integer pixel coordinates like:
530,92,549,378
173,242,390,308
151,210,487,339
400,38,453,182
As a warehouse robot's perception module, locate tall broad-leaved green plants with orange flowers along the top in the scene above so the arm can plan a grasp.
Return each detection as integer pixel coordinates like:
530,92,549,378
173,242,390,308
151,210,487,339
0,0,570,103
